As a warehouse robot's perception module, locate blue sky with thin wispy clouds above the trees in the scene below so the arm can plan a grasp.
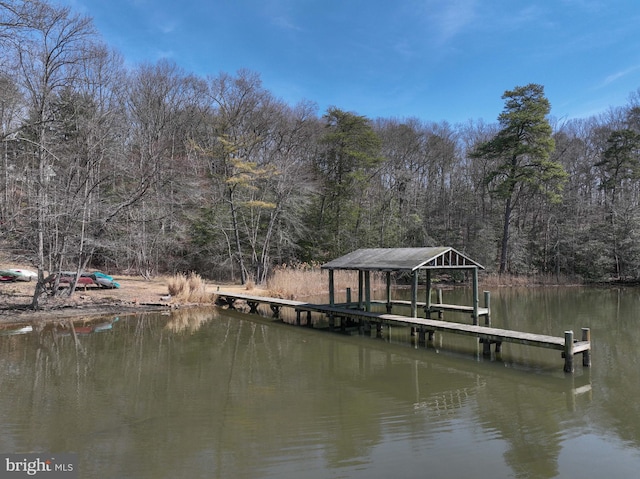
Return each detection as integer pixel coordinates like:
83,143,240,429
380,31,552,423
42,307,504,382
58,0,640,124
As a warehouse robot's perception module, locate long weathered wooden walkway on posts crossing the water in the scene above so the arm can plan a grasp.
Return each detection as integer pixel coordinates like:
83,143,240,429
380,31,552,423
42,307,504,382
217,291,591,372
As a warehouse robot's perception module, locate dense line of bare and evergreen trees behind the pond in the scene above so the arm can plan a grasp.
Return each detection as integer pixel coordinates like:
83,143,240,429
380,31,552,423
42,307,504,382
0,0,640,302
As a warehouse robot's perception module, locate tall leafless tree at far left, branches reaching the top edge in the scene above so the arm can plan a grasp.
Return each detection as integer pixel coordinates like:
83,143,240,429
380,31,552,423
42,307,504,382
6,1,95,308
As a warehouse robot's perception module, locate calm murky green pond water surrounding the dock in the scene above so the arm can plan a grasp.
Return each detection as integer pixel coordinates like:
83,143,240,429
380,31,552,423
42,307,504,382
0,289,640,479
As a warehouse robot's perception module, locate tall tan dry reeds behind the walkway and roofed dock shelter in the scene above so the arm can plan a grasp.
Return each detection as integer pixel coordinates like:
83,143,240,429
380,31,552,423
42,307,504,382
267,263,385,299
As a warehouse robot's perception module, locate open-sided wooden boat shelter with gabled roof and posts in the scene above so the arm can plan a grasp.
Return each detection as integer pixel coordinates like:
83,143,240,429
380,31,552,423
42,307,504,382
322,246,490,324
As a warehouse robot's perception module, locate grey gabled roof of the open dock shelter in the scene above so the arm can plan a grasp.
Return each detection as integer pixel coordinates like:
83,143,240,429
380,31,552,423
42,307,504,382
322,246,484,271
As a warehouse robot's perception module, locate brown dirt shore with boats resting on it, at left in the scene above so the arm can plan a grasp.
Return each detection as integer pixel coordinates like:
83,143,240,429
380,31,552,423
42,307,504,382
0,275,254,326
